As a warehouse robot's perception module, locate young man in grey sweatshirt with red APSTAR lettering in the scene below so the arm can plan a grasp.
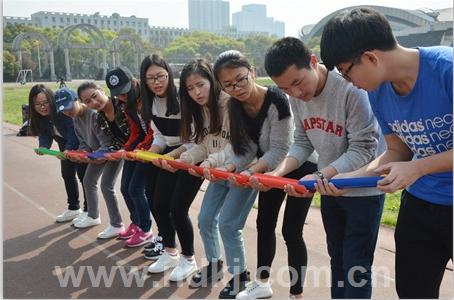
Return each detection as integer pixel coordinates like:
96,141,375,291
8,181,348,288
265,37,384,298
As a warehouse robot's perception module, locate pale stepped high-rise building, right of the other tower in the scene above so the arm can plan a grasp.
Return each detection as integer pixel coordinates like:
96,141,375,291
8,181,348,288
232,4,285,37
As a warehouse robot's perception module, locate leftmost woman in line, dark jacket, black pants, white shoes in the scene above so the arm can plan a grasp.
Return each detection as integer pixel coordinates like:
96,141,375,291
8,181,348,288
28,84,87,222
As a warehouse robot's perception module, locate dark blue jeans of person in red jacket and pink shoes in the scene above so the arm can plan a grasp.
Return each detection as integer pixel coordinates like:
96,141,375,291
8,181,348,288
121,160,151,232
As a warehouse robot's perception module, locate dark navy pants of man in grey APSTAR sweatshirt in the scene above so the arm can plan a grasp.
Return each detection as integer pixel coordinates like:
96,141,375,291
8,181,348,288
321,195,385,299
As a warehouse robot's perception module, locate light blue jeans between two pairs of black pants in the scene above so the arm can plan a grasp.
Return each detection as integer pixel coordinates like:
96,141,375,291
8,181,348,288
198,181,257,275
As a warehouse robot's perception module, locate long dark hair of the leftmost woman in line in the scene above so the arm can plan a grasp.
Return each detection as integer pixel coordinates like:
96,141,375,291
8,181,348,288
28,84,56,136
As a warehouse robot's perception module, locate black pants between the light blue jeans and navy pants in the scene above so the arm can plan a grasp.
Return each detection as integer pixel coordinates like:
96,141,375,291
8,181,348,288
257,162,317,295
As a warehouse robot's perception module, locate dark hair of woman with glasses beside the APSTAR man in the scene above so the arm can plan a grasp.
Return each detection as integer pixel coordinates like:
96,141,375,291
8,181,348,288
213,50,253,155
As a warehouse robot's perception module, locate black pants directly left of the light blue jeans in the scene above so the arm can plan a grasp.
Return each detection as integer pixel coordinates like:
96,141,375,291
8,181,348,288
153,170,203,256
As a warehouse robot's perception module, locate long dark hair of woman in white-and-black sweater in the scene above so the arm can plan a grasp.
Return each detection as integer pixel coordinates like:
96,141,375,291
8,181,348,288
140,54,180,121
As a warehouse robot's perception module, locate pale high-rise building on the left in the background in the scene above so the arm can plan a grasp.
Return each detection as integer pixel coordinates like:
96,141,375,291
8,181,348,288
188,0,230,32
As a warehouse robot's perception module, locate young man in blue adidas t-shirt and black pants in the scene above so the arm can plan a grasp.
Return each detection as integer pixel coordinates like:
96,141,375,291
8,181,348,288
321,8,453,298
